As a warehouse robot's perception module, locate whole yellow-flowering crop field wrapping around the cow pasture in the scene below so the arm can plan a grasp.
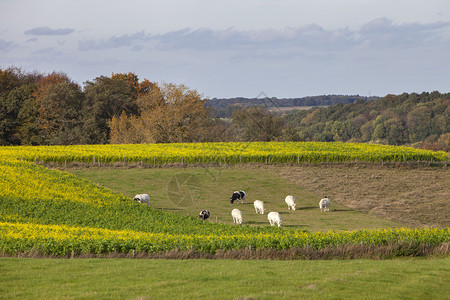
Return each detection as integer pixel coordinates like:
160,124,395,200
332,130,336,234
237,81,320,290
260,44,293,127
0,143,450,256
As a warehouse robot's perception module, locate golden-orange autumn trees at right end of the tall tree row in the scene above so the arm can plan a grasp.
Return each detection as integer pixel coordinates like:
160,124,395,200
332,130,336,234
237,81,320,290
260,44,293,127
110,83,210,143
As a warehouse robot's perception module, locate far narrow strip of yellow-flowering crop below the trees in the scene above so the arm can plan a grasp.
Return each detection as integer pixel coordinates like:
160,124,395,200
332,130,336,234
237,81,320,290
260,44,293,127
0,142,446,164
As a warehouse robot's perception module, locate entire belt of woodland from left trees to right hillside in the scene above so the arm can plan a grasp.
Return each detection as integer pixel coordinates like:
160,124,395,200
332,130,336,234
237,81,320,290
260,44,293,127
0,67,450,152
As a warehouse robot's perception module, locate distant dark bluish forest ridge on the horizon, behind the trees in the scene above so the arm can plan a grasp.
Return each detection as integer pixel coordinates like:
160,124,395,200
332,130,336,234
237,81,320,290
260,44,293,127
207,95,379,118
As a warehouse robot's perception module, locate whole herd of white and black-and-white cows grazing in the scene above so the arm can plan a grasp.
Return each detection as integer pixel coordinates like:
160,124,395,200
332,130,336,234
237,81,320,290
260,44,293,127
133,191,330,227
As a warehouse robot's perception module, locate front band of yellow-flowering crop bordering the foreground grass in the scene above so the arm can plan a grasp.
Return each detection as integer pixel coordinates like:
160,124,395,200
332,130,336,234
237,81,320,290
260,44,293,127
0,222,450,256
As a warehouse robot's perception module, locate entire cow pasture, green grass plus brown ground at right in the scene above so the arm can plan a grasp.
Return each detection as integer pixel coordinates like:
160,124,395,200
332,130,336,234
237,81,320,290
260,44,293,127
65,163,450,232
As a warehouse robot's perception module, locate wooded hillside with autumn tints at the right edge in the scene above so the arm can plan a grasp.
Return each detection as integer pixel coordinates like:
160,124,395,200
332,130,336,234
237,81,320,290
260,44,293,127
287,92,450,152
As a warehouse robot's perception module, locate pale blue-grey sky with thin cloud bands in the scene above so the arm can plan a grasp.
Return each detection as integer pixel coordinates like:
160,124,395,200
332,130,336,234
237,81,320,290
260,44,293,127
0,0,450,98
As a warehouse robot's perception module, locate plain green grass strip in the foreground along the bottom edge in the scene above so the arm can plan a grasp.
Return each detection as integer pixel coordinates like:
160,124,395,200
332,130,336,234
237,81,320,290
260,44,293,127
0,257,450,299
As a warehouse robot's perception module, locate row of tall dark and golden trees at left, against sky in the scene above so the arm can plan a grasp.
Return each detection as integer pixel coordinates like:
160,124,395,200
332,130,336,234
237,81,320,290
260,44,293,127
0,67,214,145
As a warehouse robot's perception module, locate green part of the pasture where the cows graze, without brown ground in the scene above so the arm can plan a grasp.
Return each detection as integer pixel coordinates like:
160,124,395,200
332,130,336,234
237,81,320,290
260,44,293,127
68,166,401,231
